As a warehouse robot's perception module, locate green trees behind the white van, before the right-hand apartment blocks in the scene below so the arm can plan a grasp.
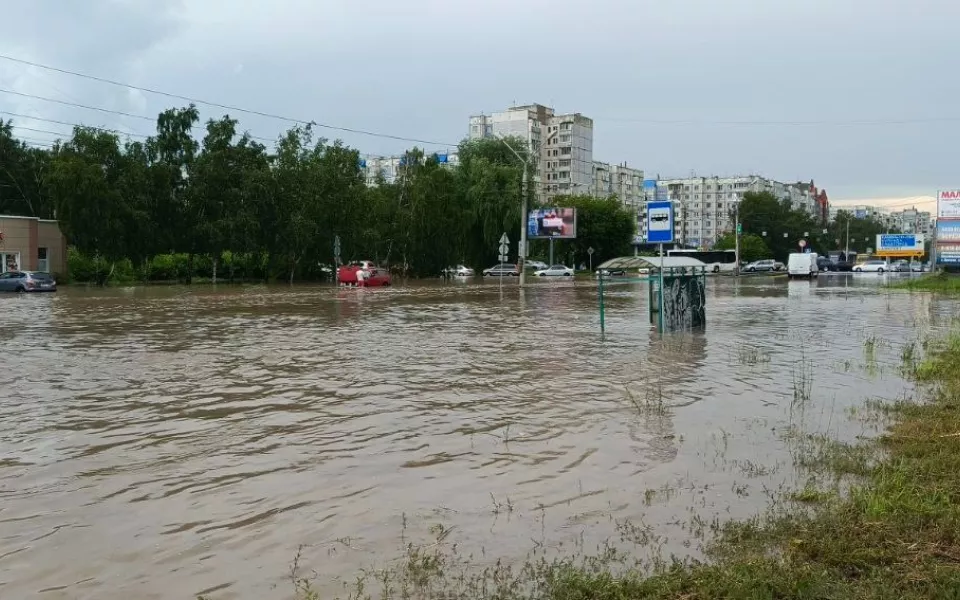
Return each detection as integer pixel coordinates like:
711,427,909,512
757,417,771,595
714,192,898,261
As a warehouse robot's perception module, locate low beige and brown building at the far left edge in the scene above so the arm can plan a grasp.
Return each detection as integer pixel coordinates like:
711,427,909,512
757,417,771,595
0,215,67,277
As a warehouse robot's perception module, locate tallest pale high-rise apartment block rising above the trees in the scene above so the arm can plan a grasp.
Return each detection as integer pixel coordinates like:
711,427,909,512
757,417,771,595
467,104,593,203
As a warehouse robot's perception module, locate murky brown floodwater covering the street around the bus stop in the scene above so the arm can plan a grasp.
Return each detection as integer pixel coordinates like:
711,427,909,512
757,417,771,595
0,276,957,600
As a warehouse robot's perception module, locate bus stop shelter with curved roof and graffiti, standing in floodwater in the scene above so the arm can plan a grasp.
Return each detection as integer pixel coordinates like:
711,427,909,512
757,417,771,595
598,256,707,333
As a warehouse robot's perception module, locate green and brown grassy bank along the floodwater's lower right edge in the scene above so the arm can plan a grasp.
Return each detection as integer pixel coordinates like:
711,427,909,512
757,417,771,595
208,334,960,600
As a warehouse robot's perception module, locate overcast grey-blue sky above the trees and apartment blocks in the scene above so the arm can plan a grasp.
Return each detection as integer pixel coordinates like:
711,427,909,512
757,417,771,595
0,0,960,208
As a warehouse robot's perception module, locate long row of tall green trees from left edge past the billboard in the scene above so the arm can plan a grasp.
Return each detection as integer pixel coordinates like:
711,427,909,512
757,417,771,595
0,110,635,283
